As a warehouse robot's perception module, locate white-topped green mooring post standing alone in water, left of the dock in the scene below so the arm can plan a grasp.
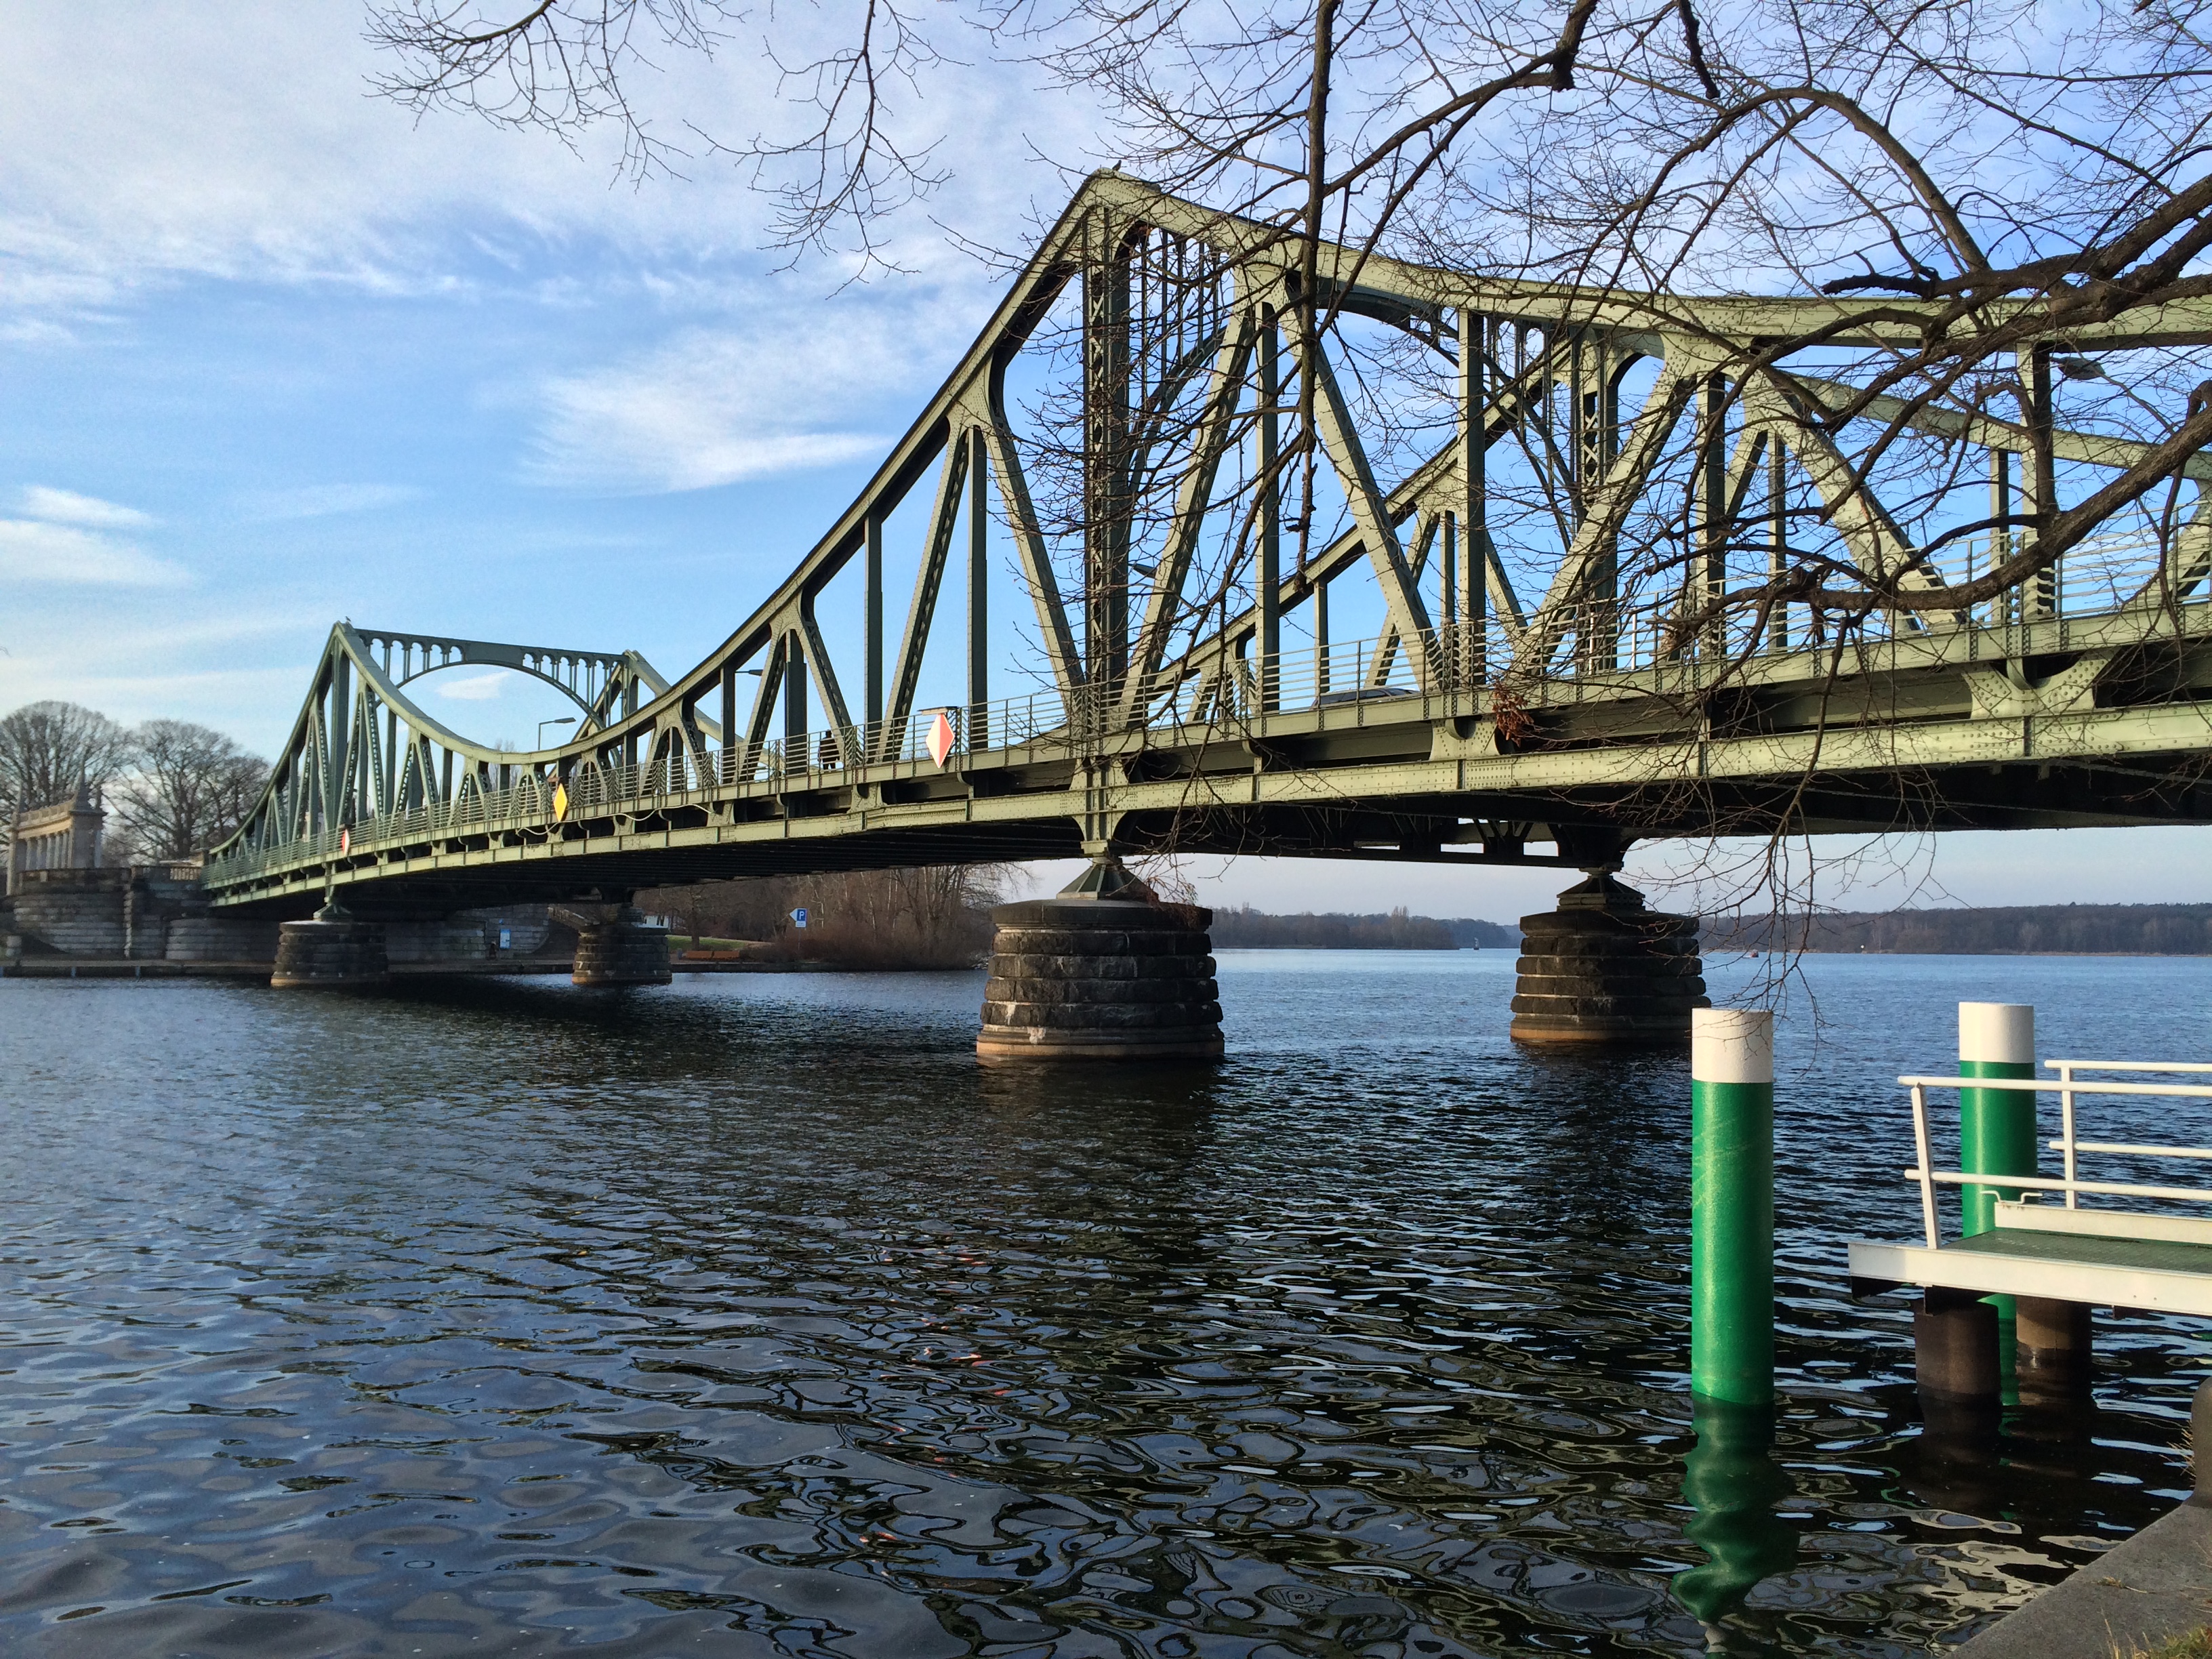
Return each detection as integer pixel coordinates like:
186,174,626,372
1690,1008,1774,1405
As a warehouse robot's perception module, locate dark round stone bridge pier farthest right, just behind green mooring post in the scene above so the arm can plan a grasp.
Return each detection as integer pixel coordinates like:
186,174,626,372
1511,869,1708,1046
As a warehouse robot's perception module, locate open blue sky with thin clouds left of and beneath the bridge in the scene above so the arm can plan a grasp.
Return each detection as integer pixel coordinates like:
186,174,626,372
0,0,2212,920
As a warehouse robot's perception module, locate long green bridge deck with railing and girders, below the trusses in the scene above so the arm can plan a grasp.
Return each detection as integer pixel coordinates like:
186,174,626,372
210,602,2212,914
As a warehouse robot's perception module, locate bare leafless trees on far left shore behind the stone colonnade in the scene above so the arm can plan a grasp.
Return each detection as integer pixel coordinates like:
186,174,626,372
0,701,270,865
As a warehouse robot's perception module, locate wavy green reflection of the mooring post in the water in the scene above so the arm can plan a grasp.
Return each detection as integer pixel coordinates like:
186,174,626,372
1675,1393,1799,1648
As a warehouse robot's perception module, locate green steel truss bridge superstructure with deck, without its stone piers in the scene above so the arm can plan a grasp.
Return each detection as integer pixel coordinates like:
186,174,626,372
206,175,2212,914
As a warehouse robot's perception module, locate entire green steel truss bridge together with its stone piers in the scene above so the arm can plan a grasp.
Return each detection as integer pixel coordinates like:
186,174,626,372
206,175,2212,1055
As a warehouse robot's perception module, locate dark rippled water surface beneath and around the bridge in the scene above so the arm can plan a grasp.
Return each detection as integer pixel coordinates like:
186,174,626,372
0,951,2212,1659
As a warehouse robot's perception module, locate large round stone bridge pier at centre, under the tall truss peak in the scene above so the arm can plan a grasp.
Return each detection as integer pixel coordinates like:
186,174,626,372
975,858,1221,1064
